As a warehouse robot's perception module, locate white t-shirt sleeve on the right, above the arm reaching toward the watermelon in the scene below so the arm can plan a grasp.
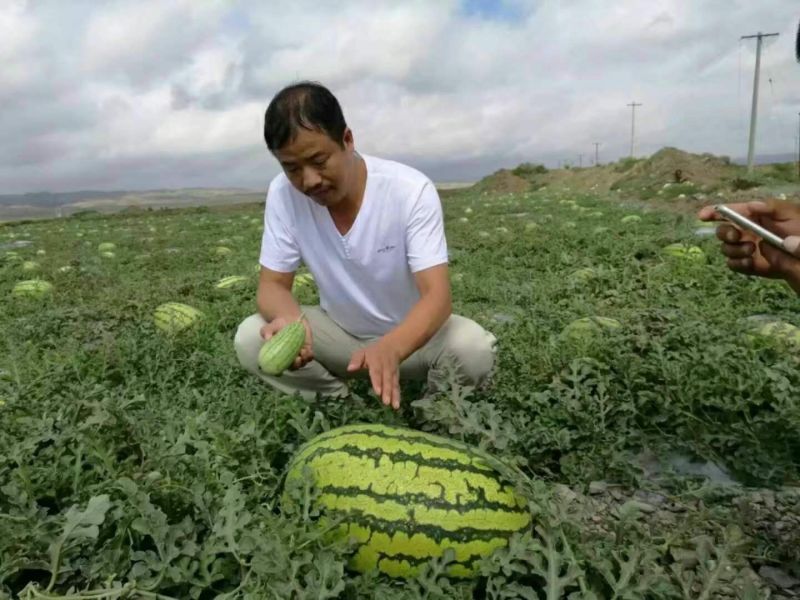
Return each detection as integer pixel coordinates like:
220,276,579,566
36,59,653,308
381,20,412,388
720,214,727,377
406,182,447,273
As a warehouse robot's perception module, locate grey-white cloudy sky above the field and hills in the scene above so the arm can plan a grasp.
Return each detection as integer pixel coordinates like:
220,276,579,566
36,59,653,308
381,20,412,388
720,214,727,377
0,0,800,193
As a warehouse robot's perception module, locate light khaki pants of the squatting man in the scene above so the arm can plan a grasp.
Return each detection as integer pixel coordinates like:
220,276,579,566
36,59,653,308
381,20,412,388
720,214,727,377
234,306,496,399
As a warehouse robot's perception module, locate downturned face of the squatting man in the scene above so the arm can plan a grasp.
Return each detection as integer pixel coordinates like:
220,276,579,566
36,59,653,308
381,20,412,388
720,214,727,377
274,129,354,207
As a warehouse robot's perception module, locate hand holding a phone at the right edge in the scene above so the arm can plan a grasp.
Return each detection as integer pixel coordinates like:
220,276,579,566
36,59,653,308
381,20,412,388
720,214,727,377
697,200,800,294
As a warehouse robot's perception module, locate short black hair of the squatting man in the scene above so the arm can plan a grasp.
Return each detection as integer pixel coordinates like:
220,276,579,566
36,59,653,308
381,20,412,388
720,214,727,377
264,81,347,151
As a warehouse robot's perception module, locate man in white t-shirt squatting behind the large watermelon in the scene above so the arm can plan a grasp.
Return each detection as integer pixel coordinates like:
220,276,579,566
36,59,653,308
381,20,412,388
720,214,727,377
234,82,496,409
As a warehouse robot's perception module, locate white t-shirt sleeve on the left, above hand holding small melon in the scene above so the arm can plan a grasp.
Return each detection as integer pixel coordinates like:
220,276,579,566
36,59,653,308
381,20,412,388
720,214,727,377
259,180,301,273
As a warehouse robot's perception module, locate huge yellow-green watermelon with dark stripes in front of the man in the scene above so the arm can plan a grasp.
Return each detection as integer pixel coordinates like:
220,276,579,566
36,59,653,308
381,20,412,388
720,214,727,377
282,424,531,577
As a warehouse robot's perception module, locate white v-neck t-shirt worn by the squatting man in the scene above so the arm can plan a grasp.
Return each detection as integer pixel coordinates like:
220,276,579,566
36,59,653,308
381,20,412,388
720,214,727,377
260,154,447,338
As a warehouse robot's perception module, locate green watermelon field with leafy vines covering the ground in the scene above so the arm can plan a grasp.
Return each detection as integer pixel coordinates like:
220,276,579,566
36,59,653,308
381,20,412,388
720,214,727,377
0,190,800,600
